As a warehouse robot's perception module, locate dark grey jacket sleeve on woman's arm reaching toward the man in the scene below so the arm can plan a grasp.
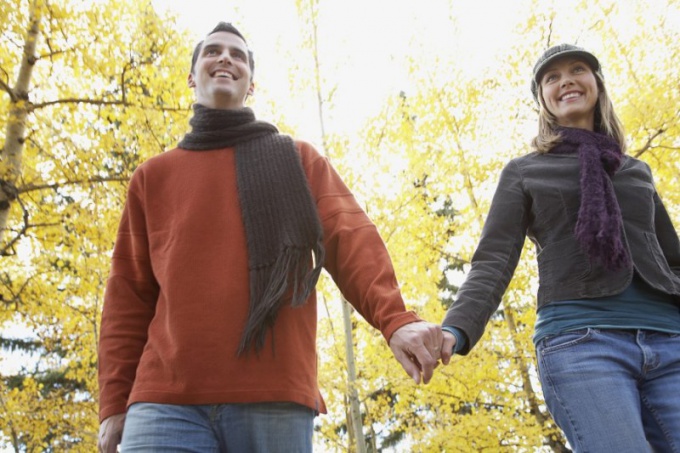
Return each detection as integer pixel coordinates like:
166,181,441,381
442,161,531,355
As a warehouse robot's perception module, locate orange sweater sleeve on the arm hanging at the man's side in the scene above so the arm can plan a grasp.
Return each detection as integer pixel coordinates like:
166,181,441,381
98,173,159,421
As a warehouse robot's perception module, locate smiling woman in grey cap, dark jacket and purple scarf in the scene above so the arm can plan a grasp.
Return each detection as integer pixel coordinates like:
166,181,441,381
442,44,680,452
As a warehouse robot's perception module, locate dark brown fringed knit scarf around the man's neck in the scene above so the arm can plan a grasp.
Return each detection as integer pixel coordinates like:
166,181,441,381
179,104,325,355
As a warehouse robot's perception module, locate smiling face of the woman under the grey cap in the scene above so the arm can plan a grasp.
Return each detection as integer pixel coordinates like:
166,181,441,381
540,56,599,131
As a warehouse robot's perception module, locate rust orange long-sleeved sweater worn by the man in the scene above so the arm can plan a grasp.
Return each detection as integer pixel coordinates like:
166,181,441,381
99,142,419,420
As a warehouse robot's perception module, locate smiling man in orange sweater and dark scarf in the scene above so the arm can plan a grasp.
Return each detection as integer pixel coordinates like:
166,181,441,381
99,22,442,453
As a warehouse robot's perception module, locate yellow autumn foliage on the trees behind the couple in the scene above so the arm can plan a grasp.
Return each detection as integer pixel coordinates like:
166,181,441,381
0,0,680,452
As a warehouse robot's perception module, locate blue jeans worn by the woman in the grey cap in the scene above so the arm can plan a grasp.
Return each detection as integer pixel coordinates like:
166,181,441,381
536,328,680,453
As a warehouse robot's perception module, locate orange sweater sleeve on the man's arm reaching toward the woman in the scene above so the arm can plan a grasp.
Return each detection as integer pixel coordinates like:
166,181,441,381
301,144,421,342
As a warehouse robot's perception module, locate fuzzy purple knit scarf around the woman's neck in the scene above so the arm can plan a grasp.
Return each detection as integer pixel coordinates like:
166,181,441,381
550,128,631,270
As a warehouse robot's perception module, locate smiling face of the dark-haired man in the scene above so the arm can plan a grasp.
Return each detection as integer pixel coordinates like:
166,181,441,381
188,32,255,109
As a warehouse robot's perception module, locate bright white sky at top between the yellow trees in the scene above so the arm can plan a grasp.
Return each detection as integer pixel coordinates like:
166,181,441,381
153,0,523,139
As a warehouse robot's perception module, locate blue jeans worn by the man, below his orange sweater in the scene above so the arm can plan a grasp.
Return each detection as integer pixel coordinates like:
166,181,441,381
120,403,315,453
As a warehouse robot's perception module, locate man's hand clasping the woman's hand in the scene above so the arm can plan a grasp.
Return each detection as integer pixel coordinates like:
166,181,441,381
390,321,443,384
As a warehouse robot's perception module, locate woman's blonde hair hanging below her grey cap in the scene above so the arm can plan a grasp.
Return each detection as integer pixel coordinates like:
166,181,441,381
531,68,626,153
